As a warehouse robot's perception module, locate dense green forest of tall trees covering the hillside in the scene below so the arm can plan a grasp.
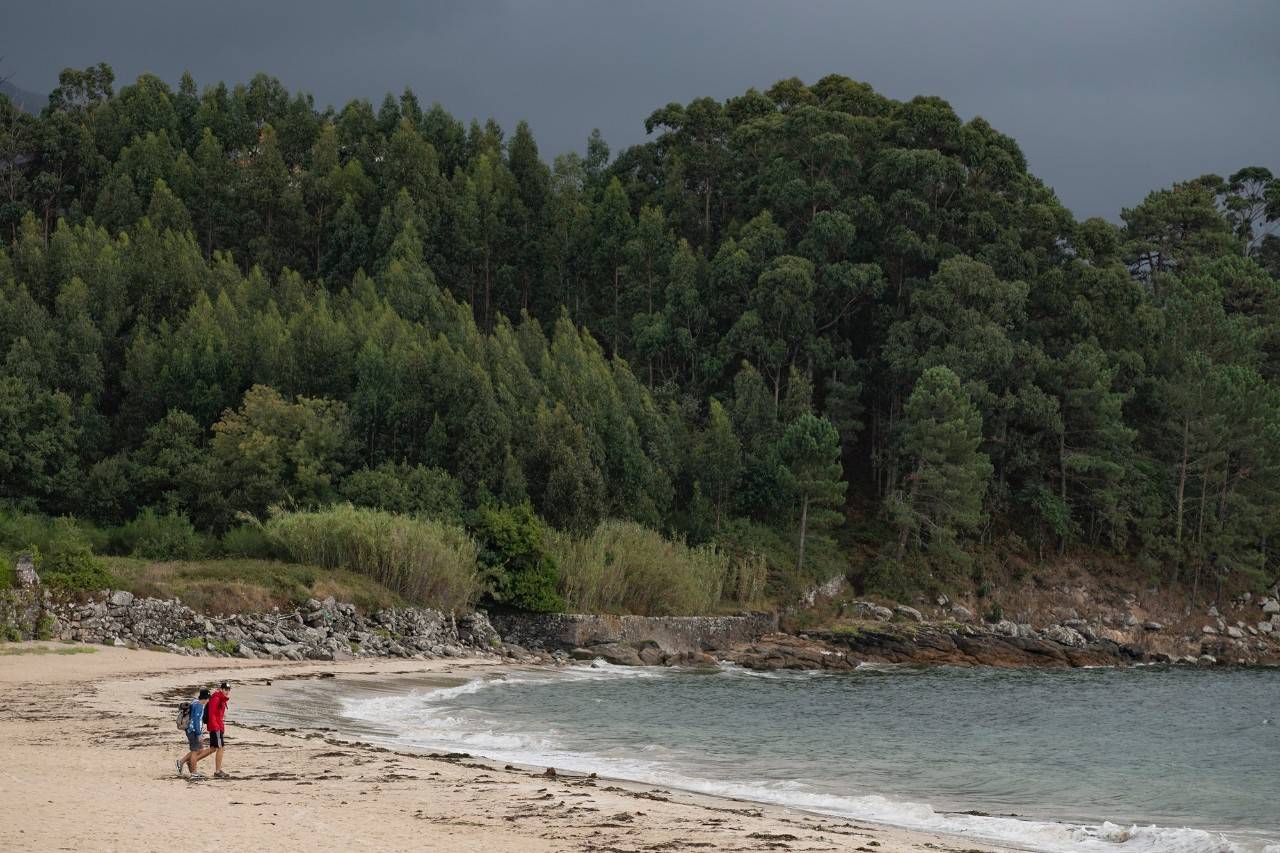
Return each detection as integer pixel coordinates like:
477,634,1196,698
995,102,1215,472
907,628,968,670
0,65,1280,608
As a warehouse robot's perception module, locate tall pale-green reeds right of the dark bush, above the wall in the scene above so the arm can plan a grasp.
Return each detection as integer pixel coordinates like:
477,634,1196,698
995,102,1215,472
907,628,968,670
550,521,737,616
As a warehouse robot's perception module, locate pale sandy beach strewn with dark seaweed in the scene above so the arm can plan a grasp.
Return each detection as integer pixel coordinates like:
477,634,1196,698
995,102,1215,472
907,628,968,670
0,643,1006,853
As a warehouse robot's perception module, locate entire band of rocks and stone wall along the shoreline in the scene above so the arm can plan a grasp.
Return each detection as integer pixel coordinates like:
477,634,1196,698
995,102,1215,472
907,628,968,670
0,550,1280,670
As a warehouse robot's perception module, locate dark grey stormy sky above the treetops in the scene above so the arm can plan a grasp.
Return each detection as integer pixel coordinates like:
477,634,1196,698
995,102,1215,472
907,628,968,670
0,0,1280,218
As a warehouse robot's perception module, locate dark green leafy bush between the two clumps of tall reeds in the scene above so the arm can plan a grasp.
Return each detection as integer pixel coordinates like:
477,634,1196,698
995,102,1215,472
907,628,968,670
471,503,564,613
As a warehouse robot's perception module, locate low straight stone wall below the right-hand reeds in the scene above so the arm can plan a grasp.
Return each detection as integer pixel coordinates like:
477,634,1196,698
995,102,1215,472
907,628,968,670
490,613,778,654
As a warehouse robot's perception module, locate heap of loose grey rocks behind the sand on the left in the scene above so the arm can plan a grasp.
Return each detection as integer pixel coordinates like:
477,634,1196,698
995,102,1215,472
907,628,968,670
37,590,500,661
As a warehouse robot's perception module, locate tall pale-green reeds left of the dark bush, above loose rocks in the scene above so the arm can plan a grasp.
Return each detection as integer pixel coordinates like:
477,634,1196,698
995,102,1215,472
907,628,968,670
265,503,481,610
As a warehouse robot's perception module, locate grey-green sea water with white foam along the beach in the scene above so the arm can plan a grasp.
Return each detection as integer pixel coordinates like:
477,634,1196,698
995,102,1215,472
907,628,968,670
232,663,1280,853
